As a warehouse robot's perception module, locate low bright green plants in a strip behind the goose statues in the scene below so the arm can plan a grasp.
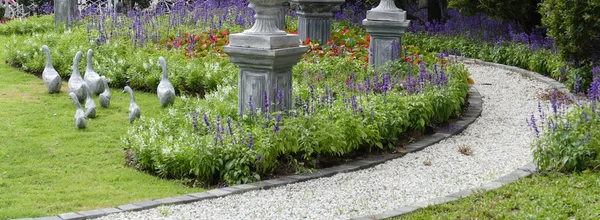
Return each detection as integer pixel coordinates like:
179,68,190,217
5,27,237,95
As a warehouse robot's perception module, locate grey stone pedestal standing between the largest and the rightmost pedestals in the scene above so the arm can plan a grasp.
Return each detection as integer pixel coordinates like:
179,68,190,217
290,0,345,44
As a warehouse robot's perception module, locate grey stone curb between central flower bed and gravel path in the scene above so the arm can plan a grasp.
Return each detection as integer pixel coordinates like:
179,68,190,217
20,86,483,220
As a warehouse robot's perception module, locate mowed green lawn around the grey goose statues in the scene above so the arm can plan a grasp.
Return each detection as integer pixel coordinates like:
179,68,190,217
0,36,203,219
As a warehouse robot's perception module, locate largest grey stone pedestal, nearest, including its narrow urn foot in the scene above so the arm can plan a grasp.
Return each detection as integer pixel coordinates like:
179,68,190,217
223,0,308,115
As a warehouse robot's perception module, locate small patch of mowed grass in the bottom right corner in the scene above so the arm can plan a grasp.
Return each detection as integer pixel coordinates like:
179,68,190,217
393,172,600,219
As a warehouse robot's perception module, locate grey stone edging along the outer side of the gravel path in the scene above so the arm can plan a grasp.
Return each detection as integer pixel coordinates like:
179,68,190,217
352,56,571,220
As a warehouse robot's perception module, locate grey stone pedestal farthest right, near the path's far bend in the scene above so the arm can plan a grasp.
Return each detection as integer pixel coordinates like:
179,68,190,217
363,0,410,67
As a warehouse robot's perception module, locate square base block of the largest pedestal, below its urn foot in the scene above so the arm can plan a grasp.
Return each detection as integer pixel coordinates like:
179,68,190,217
223,44,308,115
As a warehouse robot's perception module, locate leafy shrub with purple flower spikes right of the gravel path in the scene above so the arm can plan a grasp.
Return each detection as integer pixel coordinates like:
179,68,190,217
527,67,600,172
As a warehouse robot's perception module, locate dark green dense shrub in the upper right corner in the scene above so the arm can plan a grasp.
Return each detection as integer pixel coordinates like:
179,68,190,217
540,0,600,67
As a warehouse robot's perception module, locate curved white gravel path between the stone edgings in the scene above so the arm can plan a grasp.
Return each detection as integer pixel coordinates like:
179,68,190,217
101,64,549,219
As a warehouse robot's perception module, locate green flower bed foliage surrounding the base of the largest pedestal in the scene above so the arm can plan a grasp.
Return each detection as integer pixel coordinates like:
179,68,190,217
123,54,468,184
